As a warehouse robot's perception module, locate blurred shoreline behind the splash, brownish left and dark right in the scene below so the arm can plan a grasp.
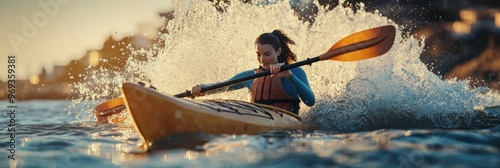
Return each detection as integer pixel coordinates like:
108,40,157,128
0,0,500,100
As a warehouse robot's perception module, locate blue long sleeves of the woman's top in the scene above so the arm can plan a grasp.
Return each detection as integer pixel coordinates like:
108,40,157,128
204,67,316,106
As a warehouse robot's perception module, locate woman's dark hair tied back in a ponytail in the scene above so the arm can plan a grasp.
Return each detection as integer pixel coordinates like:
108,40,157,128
255,30,297,64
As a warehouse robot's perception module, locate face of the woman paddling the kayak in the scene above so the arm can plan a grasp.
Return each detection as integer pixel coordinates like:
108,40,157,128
256,43,281,69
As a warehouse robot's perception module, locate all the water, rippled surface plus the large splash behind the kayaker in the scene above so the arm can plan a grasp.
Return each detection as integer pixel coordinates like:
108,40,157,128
0,1,500,167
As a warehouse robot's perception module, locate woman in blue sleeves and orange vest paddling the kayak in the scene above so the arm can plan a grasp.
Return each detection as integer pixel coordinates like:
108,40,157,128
191,30,316,114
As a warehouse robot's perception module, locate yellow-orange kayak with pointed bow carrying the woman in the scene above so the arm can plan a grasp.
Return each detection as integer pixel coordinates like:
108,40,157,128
121,83,302,148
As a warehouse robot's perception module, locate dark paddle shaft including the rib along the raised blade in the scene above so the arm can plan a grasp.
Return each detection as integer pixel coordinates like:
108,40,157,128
174,36,387,98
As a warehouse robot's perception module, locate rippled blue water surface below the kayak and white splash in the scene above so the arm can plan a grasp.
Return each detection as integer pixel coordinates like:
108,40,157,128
0,101,500,167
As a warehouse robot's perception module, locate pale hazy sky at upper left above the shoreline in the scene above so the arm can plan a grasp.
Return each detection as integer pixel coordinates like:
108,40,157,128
0,0,173,81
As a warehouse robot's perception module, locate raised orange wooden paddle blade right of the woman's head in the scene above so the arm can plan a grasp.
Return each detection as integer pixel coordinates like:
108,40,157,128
320,25,396,61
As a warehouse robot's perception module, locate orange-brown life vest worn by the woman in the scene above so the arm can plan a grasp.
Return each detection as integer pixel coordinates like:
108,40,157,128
250,67,300,114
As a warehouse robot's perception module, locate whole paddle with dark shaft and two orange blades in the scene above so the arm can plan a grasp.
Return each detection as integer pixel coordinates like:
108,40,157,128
94,25,396,122
